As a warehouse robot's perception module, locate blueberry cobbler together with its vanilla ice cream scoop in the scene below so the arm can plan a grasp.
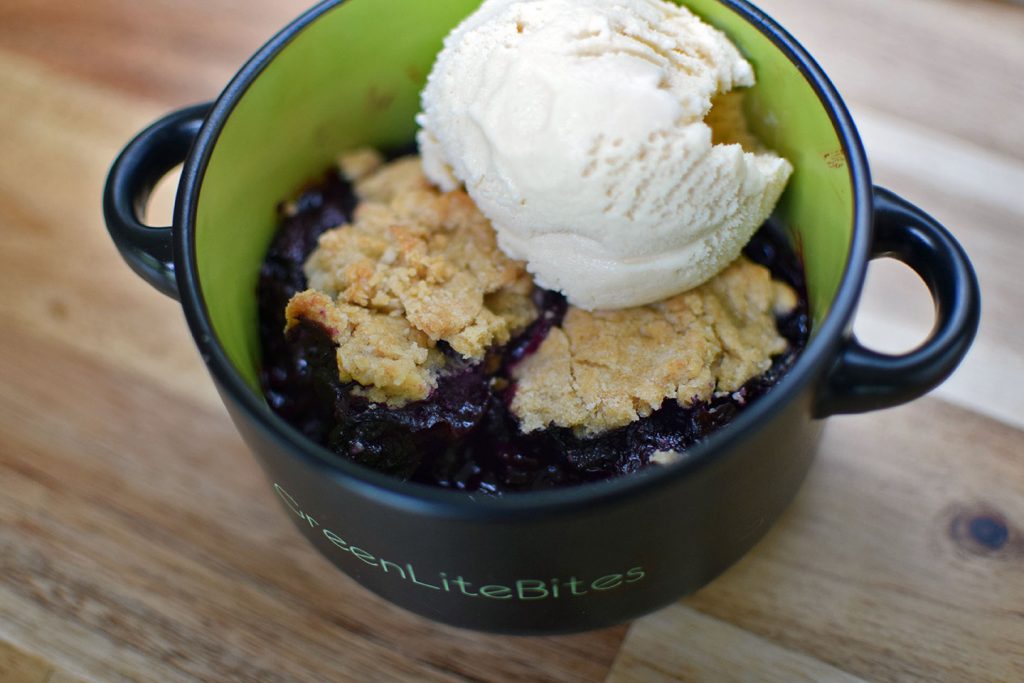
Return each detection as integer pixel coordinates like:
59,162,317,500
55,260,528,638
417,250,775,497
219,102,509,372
253,0,808,494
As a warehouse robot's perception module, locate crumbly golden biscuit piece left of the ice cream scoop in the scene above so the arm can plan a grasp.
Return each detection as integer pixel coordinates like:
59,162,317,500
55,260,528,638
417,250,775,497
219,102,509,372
286,155,537,405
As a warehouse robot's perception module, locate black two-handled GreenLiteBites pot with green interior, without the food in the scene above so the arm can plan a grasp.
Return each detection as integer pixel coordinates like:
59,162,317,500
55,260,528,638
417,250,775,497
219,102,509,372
104,0,979,633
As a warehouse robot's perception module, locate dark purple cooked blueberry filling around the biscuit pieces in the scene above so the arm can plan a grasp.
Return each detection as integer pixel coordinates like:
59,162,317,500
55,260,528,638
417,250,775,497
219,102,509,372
258,167,810,494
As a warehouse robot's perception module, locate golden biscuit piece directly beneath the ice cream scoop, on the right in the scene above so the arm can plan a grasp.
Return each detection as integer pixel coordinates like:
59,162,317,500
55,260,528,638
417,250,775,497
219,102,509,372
512,257,796,434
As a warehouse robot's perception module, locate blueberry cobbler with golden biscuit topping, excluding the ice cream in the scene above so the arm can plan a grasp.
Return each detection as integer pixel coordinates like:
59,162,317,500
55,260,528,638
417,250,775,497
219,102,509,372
259,151,809,494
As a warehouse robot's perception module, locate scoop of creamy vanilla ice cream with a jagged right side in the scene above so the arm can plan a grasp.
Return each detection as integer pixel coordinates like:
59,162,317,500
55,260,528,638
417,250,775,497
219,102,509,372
418,0,793,309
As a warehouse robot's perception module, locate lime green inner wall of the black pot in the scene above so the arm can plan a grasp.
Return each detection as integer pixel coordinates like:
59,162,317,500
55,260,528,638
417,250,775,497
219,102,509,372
196,0,854,389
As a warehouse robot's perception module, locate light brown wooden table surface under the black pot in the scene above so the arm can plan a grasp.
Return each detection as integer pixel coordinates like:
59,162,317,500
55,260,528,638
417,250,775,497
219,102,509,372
0,0,1024,683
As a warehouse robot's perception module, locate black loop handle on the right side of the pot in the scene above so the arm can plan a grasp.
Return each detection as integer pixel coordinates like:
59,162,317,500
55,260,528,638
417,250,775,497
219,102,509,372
816,187,981,418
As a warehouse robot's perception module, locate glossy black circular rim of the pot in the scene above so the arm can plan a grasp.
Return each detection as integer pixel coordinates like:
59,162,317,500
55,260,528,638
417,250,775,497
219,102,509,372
174,0,872,520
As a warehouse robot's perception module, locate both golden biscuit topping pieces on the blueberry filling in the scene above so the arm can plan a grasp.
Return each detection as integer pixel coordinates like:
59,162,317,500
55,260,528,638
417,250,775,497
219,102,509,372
286,150,797,428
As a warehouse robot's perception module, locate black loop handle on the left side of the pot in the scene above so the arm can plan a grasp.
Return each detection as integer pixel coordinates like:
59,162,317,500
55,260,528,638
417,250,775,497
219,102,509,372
103,103,212,299
